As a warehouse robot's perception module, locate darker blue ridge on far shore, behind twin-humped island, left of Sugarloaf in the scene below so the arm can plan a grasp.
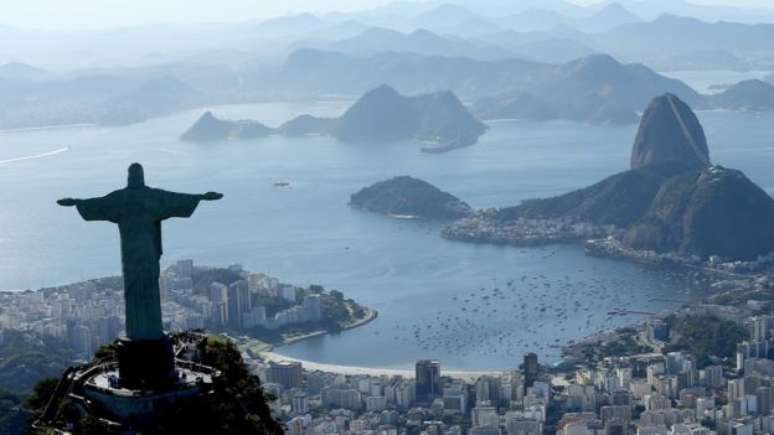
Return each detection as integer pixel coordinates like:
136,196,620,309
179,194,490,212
280,51,704,123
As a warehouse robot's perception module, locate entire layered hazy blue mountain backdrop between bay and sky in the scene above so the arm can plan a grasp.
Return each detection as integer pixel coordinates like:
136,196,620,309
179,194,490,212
0,0,774,128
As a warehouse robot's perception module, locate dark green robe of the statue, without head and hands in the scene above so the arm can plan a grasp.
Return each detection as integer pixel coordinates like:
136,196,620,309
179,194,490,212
77,187,201,340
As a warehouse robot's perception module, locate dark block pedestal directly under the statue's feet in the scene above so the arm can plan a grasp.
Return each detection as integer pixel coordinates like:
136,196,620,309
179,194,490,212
117,335,175,390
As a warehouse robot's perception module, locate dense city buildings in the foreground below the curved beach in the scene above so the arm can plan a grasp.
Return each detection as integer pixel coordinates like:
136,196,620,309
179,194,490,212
246,301,774,435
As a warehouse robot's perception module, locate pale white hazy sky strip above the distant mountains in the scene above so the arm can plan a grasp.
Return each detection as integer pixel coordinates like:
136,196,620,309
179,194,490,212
0,0,774,29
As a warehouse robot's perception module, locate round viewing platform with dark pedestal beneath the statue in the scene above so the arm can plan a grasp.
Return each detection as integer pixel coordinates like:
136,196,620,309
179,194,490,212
33,333,221,433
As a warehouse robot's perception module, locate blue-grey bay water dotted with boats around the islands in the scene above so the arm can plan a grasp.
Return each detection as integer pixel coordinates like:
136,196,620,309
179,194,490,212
0,102,774,369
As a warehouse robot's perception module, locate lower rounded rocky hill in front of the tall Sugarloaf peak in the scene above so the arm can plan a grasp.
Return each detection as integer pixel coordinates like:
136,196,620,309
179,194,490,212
624,166,774,260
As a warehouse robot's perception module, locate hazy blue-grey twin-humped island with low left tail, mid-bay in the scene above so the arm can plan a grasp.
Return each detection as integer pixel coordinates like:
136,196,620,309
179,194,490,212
181,85,487,153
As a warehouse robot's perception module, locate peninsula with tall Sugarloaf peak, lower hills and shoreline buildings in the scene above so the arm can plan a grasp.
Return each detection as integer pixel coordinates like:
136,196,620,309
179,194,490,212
442,94,774,262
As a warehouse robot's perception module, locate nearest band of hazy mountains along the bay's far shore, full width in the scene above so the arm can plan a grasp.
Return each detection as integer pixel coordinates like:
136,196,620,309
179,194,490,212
6,45,774,131
